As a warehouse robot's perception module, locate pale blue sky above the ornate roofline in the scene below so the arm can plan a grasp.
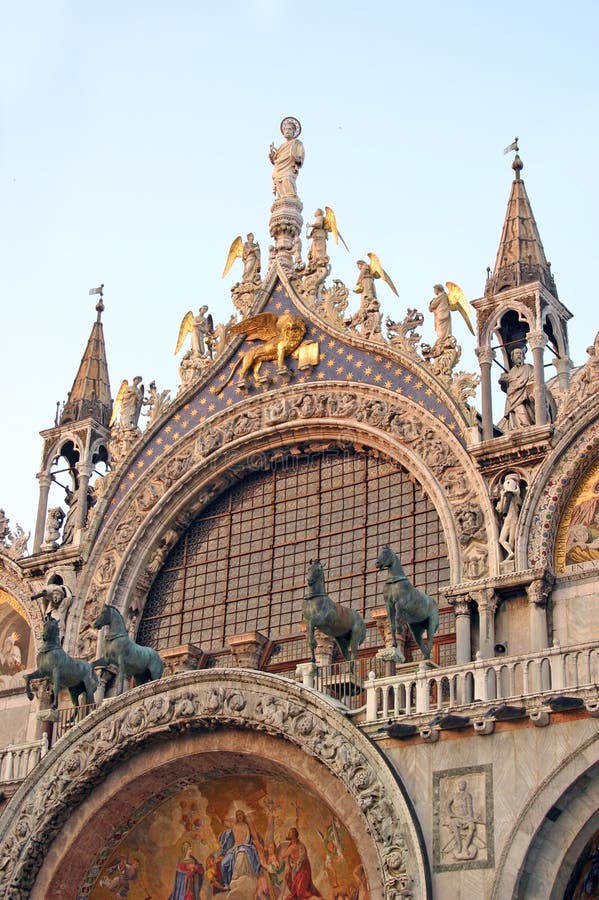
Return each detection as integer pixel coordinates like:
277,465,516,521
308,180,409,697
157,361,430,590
0,0,599,528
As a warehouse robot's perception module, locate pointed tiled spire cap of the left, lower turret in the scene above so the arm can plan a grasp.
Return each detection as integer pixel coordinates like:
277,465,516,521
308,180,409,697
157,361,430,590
60,285,112,426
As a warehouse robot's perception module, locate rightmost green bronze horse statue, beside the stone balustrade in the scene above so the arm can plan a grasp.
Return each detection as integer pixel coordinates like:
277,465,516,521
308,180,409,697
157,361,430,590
376,546,439,659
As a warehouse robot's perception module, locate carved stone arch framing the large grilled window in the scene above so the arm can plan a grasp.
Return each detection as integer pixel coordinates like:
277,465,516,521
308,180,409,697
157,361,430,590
74,382,496,648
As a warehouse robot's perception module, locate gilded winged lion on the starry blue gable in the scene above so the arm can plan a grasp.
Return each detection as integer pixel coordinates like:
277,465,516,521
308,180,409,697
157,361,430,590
218,310,306,394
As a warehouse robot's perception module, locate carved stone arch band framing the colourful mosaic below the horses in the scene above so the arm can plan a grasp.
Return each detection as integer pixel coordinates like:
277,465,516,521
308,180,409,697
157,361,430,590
0,670,426,900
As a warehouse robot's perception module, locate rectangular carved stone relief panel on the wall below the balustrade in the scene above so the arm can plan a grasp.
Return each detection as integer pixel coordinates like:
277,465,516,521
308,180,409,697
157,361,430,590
433,766,494,872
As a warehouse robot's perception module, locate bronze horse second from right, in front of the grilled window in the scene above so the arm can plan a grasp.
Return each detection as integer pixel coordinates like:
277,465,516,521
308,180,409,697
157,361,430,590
303,559,366,662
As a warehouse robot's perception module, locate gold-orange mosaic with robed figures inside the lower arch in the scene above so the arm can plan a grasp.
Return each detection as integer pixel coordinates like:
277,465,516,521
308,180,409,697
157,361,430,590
89,775,369,900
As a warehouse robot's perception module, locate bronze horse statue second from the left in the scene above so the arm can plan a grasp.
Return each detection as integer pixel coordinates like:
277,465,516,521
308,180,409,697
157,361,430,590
92,603,164,694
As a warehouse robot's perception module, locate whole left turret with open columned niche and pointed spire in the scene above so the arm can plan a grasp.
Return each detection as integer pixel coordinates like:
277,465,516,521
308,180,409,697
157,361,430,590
33,285,112,554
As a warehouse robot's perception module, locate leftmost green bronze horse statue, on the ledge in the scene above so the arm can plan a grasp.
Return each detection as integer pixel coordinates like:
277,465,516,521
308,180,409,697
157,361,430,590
24,616,98,709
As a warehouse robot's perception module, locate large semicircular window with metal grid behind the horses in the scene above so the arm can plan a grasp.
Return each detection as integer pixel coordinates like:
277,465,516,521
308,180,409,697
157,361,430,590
138,451,449,652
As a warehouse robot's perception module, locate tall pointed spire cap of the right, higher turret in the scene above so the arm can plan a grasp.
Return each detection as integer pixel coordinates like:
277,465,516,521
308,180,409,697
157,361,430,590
485,153,558,299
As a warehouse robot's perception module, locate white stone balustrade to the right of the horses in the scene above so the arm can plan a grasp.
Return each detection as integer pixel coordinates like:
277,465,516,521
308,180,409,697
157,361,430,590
364,641,599,723
